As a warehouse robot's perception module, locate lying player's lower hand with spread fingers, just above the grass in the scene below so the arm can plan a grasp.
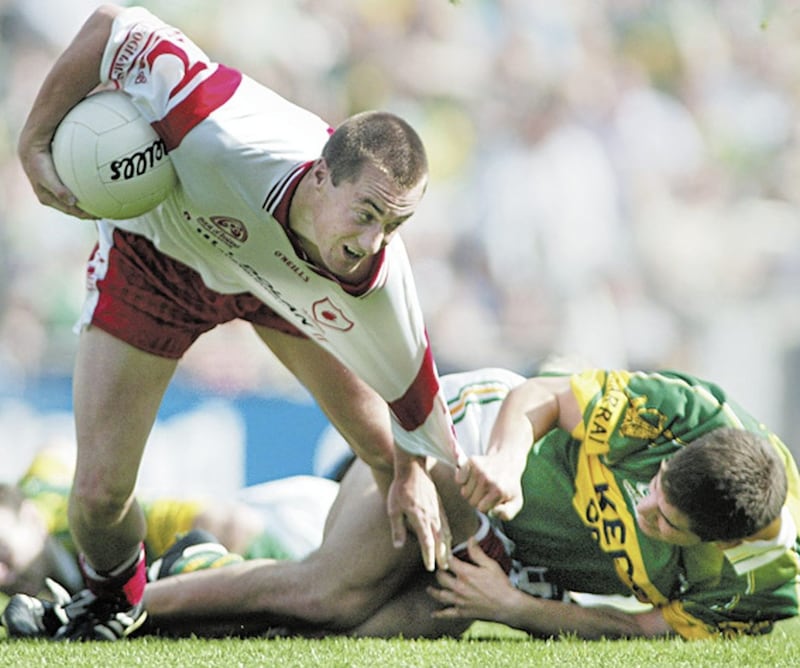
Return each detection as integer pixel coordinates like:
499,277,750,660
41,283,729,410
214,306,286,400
427,537,519,621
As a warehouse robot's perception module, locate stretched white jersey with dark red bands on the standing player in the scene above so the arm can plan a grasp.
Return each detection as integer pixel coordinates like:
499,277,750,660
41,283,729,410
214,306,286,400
99,8,463,464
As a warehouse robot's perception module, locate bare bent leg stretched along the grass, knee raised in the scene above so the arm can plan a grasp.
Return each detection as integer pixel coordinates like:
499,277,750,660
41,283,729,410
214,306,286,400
144,462,422,630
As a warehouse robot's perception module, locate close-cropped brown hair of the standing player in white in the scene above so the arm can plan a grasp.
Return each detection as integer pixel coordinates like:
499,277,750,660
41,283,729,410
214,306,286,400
322,111,428,190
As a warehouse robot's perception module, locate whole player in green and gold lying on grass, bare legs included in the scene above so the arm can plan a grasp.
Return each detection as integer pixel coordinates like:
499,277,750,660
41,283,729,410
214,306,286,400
5,370,800,639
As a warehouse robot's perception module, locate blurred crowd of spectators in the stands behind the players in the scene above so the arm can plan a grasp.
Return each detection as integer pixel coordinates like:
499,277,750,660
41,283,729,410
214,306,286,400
0,0,800,470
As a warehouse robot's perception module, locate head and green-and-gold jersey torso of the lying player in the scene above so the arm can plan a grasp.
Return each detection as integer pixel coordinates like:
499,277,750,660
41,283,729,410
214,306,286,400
456,370,800,638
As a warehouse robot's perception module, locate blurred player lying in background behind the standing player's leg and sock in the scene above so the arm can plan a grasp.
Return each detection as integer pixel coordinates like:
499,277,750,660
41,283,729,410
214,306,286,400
0,446,338,595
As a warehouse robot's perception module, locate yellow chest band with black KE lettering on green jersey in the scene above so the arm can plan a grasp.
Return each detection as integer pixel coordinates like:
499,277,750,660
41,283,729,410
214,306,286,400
572,443,667,606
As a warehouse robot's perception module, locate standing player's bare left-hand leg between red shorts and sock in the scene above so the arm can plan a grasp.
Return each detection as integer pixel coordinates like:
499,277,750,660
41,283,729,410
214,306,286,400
69,327,177,570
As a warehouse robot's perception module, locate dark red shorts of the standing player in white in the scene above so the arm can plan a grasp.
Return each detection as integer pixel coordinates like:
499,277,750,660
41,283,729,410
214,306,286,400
87,229,305,359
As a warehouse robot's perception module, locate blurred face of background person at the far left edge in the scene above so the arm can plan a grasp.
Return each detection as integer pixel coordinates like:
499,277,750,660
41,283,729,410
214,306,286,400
0,500,47,595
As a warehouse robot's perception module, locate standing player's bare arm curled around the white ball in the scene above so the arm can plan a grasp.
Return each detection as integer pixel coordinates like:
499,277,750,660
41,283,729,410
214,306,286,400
17,5,122,218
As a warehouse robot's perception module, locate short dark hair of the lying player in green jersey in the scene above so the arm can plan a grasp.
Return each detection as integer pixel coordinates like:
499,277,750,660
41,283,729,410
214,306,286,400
661,427,788,541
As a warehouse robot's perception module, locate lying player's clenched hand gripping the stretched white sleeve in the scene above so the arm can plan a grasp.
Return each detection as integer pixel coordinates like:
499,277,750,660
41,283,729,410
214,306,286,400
456,454,522,520
